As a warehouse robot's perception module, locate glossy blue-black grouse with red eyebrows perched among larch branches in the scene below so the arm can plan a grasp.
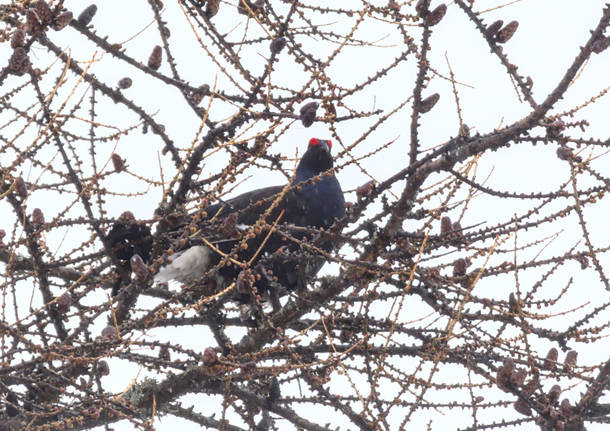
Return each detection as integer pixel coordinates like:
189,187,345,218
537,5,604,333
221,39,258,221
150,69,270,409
155,138,345,308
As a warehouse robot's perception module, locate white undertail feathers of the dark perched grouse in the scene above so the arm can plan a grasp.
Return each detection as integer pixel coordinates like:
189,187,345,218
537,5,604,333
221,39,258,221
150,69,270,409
155,245,210,283
